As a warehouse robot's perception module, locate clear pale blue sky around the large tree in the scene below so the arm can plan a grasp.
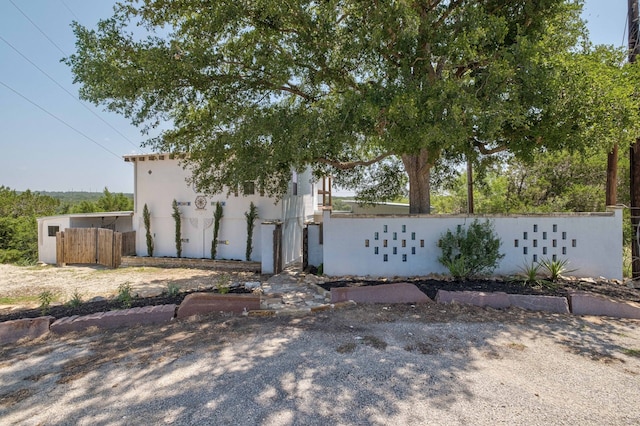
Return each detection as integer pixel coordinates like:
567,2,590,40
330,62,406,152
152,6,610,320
0,0,627,192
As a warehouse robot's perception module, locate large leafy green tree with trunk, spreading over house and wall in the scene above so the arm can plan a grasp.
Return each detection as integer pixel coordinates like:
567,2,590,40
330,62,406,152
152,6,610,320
65,0,640,213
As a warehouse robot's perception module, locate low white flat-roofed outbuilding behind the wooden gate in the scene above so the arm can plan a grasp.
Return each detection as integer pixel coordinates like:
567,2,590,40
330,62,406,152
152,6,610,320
38,212,133,264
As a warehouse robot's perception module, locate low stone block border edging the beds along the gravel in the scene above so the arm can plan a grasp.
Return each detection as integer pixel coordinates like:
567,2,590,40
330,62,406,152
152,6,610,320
0,283,640,344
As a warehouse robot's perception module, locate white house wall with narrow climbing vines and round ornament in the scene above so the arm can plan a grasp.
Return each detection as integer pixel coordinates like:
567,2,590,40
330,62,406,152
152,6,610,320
125,155,313,263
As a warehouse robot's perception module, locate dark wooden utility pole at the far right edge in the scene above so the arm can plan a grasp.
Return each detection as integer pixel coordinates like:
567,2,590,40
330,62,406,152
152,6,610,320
627,0,640,280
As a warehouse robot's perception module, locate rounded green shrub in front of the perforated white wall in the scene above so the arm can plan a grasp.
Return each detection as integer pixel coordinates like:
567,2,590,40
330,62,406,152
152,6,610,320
438,219,504,279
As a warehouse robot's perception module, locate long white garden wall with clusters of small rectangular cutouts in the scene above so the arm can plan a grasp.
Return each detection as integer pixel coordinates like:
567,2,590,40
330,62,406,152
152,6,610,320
322,208,622,279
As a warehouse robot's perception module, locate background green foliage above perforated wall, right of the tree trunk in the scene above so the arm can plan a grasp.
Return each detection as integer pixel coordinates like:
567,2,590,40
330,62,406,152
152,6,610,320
433,149,630,216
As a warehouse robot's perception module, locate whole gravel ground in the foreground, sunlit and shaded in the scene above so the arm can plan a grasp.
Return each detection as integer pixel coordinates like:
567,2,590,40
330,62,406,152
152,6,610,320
0,303,640,425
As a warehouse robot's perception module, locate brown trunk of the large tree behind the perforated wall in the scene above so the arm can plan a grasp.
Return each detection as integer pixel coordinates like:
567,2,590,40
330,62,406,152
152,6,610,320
402,149,432,214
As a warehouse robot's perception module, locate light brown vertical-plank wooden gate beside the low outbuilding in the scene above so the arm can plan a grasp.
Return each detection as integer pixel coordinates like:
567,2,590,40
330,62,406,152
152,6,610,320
56,228,135,268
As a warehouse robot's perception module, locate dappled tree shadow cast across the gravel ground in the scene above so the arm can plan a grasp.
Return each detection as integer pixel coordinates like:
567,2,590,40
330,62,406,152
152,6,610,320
0,304,639,425
